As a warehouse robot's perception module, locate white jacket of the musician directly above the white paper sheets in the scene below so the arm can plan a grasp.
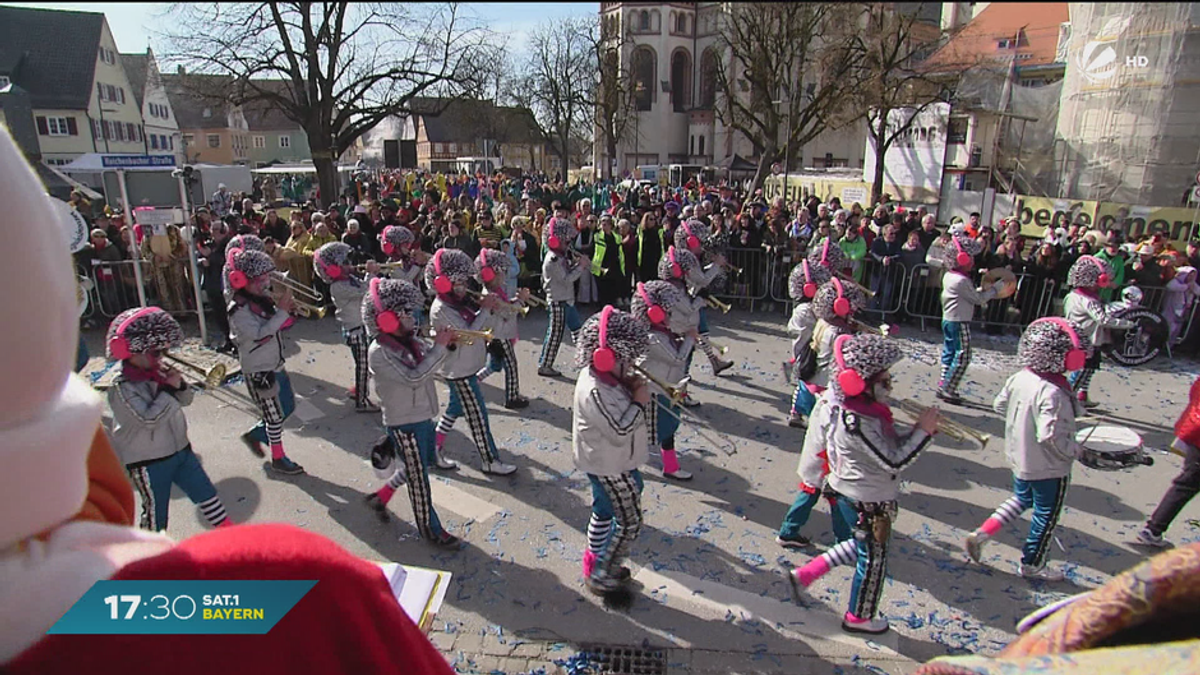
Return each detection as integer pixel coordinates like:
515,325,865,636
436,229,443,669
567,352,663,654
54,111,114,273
367,340,446,426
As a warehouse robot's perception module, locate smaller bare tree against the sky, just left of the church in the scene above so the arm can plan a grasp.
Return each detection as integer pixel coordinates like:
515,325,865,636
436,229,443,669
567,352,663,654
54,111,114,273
516,17,595,175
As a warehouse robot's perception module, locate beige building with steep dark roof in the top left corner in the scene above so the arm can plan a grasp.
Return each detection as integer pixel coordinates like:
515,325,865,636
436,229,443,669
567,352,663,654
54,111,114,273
0,7,145,165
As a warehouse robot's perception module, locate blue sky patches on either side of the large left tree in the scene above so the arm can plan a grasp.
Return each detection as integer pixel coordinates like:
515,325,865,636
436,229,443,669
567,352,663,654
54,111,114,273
2,2,600,54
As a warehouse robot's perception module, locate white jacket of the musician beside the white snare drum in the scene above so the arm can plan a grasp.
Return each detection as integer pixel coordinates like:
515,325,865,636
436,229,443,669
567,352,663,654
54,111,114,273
992,369,1084,480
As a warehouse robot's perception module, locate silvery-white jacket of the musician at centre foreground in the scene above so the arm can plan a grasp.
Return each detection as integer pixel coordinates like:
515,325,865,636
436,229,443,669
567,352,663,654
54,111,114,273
571,368,649,476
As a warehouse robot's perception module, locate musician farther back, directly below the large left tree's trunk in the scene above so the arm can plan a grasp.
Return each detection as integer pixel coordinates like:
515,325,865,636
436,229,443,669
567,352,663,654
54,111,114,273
312,241,379,412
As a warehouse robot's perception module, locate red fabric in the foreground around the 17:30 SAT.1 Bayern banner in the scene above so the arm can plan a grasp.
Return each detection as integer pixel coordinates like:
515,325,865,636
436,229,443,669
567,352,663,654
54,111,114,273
5,525,454,675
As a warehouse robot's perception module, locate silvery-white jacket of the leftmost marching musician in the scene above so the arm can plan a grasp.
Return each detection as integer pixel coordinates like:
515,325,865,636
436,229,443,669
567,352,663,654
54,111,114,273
108,378,192,466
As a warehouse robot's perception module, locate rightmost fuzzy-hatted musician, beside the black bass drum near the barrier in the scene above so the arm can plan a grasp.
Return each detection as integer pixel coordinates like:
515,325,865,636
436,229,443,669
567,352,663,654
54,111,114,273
1062,256,1133,408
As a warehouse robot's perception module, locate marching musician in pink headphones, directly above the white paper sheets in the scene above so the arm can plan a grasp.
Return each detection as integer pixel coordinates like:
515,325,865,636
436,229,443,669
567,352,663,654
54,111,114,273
360,277,461,550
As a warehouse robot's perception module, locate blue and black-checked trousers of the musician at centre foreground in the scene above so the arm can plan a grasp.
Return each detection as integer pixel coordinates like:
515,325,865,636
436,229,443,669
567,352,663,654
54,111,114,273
588,468,643,579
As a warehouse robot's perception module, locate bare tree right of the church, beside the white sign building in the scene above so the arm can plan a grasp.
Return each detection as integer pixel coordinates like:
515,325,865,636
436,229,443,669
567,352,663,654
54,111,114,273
853,2,955,203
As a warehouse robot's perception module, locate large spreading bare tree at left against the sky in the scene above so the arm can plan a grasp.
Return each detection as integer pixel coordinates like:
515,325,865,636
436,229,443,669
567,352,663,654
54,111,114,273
160,2,493,204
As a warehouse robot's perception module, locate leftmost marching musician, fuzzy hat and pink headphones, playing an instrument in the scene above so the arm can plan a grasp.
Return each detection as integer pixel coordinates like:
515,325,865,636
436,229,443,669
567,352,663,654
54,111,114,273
106,306,233,532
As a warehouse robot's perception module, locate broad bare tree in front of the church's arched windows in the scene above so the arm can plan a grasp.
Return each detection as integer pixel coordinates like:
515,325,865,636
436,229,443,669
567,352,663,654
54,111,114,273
714,2,863,190
